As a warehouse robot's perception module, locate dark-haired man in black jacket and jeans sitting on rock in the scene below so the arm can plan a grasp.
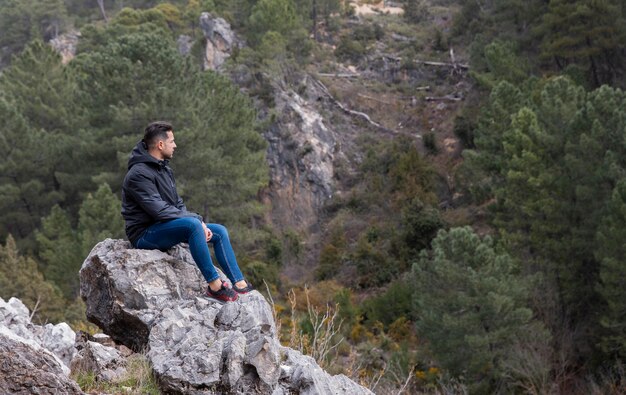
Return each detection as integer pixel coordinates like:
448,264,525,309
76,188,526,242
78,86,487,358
122,122,252,302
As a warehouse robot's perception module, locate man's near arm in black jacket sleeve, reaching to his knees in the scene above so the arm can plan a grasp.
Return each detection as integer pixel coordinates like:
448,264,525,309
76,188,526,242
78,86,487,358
127,173,202,221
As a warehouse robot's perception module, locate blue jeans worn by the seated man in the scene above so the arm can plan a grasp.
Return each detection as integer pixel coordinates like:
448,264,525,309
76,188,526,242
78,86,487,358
135,217,243,284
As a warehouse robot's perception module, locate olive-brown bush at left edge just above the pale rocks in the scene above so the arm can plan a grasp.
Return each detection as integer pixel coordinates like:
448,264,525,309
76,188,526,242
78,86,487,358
0,235,64,323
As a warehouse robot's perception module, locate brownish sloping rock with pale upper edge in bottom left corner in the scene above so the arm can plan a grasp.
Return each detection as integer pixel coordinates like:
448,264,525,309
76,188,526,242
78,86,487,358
0,326,83,394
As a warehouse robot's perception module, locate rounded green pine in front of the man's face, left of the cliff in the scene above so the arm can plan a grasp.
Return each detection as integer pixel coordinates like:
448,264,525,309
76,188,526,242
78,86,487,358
173,72,267,232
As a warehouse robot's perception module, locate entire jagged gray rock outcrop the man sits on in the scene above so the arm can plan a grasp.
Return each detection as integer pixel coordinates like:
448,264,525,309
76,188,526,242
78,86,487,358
80,239,371,394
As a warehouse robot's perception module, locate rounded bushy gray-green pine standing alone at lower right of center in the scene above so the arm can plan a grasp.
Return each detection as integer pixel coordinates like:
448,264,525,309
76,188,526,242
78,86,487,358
413,227,543,393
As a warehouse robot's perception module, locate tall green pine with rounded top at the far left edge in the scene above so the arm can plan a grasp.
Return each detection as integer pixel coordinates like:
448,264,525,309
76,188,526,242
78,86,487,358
0,41,82,241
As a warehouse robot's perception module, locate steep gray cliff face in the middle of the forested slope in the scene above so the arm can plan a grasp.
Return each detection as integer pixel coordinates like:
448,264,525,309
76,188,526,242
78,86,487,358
265,76,361,231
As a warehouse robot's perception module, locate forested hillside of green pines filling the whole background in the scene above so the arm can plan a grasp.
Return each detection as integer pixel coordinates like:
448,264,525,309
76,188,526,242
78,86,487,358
0,0,626,394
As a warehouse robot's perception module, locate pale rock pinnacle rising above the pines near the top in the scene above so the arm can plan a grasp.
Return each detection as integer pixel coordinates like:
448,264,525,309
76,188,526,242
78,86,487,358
200,12,242,70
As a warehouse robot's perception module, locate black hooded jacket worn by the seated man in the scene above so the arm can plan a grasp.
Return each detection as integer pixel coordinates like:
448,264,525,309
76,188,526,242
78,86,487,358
122,141,202,245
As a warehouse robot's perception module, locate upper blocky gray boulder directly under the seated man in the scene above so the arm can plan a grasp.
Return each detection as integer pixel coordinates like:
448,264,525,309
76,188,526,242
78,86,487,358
80,239,203,352
